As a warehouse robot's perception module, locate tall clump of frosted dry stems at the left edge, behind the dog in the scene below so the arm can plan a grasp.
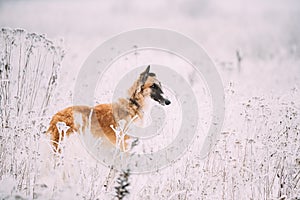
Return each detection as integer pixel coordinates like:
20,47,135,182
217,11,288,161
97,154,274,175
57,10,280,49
0,28,64,198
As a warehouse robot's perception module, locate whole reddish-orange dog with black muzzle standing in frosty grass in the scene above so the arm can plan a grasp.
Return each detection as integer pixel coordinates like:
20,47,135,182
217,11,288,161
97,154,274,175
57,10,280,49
47,65,171,152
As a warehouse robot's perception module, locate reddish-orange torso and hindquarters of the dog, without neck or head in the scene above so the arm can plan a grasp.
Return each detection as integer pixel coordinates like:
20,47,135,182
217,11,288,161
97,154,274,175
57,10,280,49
47,104,128,151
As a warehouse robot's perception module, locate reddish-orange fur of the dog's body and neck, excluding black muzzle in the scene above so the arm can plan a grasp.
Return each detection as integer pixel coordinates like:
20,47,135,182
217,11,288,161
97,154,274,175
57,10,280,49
47,66,156,151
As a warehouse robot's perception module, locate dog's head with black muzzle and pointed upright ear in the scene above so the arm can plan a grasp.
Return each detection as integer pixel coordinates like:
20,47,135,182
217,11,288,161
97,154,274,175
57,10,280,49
138,65,171,106
